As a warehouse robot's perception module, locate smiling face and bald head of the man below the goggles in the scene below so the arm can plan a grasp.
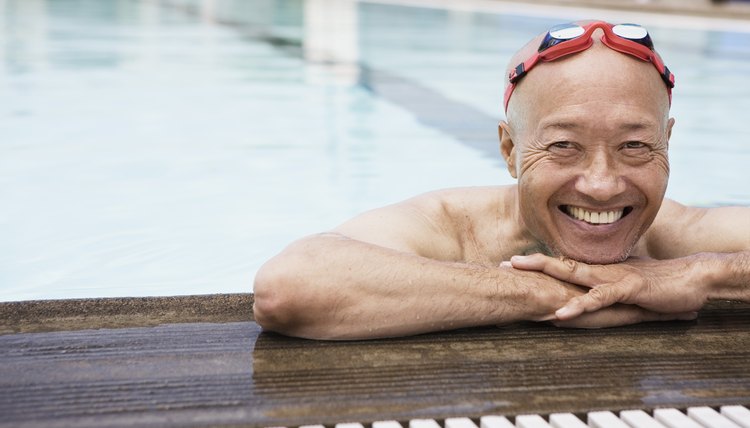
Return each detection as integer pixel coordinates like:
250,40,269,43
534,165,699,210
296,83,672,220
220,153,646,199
501,39,674,264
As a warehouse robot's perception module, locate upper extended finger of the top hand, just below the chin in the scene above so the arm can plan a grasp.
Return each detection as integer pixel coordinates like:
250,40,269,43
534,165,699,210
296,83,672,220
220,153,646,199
510,254,599,287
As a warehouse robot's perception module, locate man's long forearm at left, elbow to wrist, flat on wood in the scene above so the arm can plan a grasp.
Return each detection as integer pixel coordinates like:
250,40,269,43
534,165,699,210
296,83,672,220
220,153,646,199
255,234,548,339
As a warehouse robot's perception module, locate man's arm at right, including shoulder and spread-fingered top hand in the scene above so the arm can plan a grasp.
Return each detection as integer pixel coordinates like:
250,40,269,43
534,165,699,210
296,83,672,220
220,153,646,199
512,201,750,320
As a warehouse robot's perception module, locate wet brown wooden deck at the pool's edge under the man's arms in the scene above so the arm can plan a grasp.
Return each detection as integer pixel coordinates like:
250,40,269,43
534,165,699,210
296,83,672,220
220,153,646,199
0,295,750,427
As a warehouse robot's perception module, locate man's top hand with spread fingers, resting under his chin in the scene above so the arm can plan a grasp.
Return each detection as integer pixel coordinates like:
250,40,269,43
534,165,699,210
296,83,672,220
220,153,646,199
510,254,708,321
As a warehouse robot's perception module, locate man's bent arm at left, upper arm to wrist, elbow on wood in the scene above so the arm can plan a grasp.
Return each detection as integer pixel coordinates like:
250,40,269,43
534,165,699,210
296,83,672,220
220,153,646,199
254,189,581,339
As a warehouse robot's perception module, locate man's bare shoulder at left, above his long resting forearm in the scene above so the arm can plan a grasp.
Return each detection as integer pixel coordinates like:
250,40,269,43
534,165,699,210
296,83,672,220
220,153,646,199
334,186,507,261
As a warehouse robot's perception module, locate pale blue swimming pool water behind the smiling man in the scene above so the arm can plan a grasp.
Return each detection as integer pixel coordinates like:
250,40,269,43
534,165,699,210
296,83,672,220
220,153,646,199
0,0,750,301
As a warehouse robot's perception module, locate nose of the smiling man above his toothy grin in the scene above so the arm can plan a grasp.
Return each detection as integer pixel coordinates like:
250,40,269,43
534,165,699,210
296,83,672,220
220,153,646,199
575,150,627,202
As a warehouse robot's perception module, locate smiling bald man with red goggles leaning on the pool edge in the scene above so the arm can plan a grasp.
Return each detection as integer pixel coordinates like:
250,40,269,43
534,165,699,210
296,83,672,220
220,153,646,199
254,22,750,339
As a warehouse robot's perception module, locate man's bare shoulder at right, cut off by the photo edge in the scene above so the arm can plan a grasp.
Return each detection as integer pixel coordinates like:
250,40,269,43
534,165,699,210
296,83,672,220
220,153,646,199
644,199,750,259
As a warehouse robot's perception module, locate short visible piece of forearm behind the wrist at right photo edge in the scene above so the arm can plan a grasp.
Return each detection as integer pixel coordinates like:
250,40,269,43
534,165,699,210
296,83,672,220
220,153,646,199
700,251,750,302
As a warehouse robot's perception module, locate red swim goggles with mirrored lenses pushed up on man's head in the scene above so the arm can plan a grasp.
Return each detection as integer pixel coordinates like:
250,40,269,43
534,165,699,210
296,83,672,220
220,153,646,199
503,21,674,112
